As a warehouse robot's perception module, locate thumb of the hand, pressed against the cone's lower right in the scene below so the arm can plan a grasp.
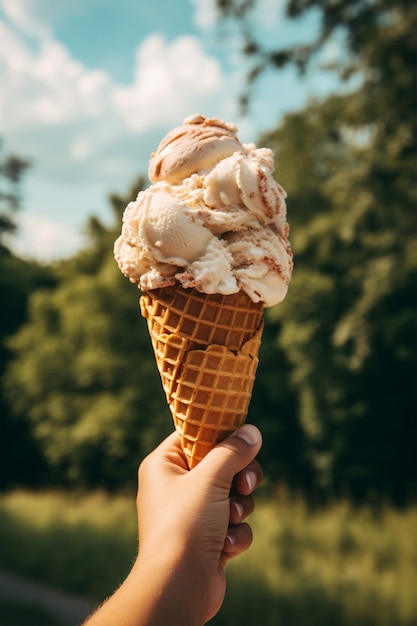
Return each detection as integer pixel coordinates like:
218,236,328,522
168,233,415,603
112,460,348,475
194,424,262,484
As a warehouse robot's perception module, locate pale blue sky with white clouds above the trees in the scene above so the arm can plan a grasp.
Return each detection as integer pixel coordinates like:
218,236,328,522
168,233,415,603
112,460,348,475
0,0,338,262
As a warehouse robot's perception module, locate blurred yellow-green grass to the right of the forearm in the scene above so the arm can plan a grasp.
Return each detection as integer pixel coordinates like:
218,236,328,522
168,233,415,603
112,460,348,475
211,501,417,626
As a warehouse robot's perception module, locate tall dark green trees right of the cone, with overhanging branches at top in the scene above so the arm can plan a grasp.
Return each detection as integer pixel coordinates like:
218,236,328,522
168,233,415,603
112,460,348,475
218,0,417,502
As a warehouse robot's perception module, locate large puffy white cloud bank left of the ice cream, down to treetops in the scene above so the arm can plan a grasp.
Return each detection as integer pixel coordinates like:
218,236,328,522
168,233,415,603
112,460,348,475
0,0,242,260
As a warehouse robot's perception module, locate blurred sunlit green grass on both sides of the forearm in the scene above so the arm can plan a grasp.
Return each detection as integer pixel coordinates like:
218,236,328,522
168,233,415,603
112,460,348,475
0,492,417,626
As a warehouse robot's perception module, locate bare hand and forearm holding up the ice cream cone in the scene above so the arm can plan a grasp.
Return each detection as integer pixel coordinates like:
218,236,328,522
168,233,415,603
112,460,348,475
84,424,262,626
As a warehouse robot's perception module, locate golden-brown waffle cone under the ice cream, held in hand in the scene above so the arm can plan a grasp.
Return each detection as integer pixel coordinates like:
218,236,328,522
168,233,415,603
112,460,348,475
140,283,263,469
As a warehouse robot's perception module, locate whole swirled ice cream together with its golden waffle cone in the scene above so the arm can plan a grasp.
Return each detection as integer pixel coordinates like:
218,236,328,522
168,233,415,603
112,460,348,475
114,115,293,467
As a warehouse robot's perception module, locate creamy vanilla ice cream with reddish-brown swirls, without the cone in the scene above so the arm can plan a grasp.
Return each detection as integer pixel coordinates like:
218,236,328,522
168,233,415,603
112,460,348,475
114,115,293,306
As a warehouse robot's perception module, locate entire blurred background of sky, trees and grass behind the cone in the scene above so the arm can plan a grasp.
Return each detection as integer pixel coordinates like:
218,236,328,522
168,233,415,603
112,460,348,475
0,0,417,626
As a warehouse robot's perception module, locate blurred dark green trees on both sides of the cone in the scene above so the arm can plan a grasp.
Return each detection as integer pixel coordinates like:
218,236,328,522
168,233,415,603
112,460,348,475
0,0,417,506
